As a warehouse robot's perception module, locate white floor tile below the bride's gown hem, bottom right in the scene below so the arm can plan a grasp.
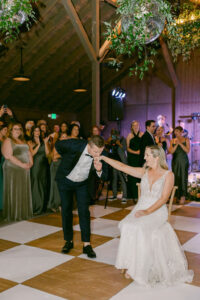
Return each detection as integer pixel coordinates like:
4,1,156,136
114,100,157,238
110,282,200,300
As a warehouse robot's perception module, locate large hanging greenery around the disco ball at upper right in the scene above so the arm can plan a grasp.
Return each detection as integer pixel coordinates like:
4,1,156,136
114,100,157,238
105,0,200,79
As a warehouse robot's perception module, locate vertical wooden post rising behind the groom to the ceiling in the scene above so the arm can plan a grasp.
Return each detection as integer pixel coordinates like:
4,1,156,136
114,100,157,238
92,0,100,126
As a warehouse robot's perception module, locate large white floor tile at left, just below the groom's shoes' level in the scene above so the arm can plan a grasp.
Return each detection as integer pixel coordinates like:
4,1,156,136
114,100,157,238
0,245,73,283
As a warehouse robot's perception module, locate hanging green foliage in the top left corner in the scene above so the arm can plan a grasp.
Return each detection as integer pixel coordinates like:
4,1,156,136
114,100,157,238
0,0,37,42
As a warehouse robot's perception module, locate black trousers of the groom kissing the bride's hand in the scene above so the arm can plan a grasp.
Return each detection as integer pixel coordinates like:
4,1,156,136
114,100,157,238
57,178,90,242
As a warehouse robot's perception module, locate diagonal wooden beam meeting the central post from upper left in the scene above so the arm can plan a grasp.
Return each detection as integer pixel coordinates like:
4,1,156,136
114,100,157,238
61,0,97,61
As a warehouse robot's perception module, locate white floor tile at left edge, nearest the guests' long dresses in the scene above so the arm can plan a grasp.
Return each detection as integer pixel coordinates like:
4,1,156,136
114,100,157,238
0,221,61,244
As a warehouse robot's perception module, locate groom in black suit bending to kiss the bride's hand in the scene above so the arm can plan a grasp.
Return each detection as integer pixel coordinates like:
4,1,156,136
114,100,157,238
55,135,108,258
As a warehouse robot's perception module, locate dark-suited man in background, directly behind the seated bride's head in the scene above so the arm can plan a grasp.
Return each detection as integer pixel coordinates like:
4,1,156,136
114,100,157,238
140,120,156,166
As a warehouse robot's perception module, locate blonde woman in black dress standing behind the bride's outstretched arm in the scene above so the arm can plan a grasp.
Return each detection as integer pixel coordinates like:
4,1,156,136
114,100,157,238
126,121,143,202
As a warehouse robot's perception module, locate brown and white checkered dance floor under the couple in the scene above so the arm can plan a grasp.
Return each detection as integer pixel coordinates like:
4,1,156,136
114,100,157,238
0,200,200,300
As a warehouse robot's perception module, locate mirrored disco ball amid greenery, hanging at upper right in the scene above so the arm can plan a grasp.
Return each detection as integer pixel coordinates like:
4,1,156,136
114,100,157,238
122,0,165,44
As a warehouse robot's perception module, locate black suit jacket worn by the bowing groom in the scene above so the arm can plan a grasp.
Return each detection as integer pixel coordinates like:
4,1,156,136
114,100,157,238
55,139,108,193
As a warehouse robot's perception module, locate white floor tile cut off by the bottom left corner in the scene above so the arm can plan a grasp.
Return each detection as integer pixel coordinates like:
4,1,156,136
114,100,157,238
0,284,67,300
